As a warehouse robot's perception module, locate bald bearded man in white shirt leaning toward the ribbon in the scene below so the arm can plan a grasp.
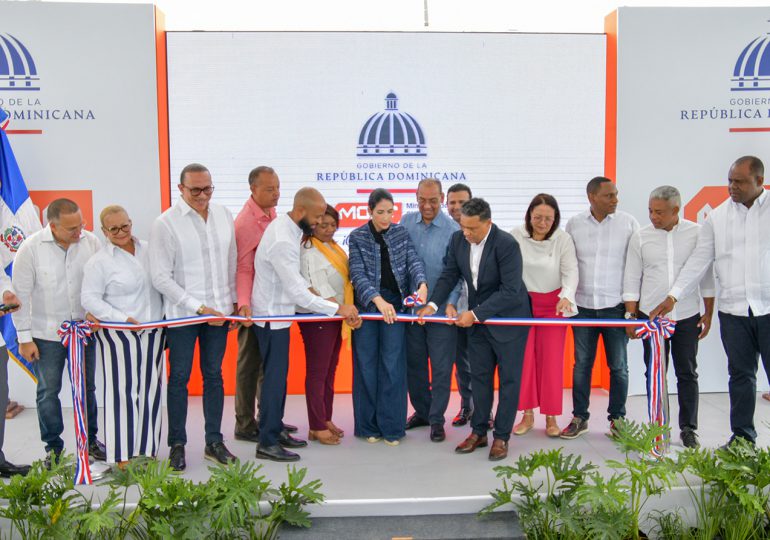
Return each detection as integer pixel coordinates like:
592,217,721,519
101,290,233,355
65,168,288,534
251,188,361,461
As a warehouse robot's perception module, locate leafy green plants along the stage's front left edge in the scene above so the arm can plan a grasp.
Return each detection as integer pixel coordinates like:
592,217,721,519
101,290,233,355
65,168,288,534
0,457,324,540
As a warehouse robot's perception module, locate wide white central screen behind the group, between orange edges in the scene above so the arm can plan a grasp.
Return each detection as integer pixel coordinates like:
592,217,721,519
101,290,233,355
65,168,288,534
168,32,605,241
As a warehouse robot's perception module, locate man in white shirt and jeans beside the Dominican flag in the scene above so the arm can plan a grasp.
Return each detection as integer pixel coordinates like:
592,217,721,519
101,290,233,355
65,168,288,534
13,199,106,466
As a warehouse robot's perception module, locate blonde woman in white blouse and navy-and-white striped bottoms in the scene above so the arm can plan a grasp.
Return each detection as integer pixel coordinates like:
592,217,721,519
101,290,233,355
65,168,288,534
81,206,165,464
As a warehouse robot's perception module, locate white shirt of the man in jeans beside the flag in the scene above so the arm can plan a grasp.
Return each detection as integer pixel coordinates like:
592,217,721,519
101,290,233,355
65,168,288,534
12,225,102,343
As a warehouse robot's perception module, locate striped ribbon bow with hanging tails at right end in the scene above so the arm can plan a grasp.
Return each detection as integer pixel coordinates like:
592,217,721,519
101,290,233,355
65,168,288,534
636,318,676,457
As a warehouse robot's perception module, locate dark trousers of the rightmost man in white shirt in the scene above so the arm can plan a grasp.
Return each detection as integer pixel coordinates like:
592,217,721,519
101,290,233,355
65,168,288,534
712,311,770,441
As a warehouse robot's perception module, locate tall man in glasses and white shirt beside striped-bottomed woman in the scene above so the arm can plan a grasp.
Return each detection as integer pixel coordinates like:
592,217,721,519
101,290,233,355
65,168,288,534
150,163,237,471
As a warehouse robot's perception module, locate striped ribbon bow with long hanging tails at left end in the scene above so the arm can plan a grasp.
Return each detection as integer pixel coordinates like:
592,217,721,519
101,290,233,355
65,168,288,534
58,321,93,485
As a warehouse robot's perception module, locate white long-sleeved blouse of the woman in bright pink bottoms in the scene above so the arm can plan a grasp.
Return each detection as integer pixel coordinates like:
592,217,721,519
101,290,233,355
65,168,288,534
511,225,578,304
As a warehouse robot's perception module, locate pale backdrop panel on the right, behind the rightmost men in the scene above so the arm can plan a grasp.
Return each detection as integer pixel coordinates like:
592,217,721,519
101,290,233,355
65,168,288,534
617,7,770,393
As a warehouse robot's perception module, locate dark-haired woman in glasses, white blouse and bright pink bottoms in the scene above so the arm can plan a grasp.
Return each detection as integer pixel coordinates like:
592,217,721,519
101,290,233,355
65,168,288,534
511,193,578,437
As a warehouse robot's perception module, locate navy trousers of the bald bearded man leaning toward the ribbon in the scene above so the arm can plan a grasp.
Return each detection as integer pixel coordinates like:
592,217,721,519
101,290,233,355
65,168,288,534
251,323,290,446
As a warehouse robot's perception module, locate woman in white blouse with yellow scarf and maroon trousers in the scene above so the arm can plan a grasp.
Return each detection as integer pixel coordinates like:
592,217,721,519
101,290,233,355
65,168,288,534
299,205,353,444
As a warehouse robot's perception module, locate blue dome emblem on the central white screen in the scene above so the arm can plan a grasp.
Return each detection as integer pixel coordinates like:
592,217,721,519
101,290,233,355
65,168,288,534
357,92,428,158
